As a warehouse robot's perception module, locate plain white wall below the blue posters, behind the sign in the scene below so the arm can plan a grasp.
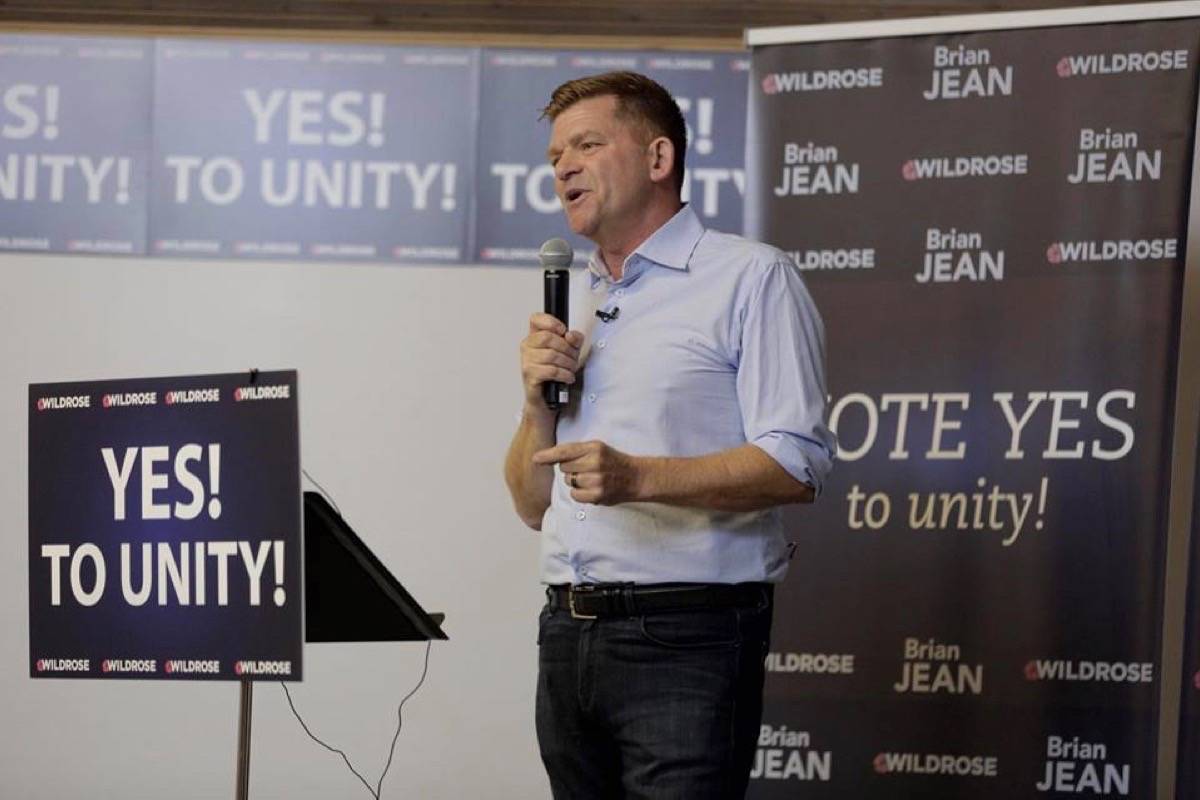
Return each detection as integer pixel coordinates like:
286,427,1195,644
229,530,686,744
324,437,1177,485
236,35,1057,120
0,255,550,800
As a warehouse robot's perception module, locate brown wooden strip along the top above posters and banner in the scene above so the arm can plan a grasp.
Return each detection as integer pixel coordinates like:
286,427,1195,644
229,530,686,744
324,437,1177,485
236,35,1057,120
0,0,1171,47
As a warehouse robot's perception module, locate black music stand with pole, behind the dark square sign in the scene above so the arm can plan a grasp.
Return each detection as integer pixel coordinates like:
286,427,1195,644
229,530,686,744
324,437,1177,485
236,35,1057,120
235,492,449,800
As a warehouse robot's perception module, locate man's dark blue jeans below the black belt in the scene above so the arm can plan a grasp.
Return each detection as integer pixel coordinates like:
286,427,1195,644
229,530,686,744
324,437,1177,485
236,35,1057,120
536,588,772,800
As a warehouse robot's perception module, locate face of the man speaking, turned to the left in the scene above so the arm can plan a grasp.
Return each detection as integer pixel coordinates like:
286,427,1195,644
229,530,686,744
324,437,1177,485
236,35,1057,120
546,95,653,246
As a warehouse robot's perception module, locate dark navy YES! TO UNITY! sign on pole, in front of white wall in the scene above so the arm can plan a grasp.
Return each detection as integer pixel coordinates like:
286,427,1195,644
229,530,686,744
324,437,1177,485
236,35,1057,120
29,372,304,680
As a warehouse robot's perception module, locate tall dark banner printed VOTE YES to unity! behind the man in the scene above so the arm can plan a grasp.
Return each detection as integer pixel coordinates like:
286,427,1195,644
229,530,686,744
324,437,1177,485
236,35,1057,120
746,20,1200,800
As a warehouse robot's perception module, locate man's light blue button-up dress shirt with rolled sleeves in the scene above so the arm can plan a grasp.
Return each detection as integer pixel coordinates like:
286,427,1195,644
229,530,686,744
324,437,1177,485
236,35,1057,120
541,205,835,584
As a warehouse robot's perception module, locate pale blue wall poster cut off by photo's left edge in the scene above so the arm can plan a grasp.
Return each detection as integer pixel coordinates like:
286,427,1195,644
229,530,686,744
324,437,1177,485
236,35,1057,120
0,35,152,254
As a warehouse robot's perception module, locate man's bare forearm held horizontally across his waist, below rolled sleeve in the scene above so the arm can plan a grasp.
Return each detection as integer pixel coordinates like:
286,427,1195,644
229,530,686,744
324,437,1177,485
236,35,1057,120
634,444,816,511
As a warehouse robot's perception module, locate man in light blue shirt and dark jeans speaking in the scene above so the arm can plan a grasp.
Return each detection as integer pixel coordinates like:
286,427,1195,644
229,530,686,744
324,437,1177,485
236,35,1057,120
505,72,834,800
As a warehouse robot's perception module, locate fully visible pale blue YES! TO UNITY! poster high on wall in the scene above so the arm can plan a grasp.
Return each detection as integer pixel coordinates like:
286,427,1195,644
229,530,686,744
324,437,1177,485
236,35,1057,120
150,40,479,264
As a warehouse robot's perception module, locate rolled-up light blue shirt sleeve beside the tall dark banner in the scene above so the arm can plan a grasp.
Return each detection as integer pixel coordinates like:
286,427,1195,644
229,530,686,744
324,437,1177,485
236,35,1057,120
737,259,836,494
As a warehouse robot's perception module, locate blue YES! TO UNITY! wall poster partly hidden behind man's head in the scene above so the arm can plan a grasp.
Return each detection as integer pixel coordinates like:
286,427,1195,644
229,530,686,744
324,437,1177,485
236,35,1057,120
475,50,749,264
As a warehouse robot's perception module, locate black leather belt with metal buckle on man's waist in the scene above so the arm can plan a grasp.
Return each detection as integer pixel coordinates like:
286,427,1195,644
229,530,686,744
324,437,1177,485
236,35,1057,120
546,583,772,619
